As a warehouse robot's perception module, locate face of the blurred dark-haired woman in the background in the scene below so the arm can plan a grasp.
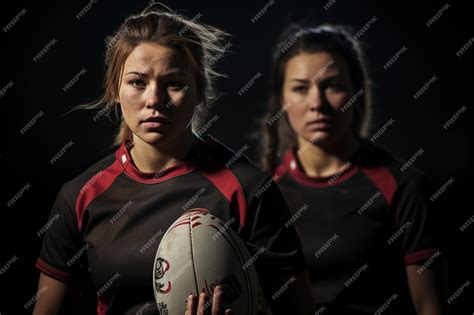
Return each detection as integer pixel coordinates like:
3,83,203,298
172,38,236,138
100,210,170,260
282,52,355,146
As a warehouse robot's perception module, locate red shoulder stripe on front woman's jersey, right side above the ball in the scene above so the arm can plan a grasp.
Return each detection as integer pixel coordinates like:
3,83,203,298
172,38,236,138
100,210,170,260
203,167,247,226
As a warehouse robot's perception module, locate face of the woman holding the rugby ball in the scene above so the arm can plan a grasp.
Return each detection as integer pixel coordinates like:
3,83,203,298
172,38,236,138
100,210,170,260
117,43,198,145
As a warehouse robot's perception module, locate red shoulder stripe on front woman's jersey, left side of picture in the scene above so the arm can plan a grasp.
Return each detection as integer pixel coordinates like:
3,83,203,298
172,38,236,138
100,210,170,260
76,160,123,231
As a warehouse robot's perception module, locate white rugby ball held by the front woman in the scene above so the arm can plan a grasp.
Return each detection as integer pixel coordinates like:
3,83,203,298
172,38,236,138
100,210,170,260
153,208,258,315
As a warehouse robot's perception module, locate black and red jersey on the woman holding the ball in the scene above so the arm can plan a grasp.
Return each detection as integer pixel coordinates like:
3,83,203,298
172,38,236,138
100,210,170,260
37,136,305,314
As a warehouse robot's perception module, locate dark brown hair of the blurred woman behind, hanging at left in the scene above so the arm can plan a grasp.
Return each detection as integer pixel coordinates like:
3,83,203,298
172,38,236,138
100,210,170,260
260,24,372,174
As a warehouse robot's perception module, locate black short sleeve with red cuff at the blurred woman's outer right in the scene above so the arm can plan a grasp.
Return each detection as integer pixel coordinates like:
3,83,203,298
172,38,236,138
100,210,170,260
396,176,439,265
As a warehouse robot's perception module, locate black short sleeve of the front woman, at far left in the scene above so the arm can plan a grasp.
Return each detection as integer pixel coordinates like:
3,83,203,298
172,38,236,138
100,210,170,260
36,186,87,282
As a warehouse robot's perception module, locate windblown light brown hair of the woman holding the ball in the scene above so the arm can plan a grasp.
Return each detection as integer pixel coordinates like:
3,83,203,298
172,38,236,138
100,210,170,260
78,3,228,145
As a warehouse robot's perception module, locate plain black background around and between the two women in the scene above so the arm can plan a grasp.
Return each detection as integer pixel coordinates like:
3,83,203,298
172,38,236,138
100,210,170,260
0,0,474,315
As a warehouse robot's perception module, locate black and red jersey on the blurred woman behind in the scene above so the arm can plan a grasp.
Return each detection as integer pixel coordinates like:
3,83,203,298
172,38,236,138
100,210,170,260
275,142,439,315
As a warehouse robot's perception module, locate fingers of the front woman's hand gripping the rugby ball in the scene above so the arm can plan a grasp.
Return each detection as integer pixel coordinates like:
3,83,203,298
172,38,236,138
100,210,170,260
186,286,233,315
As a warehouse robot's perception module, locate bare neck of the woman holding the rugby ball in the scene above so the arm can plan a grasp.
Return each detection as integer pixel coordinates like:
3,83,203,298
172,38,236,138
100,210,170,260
130,128,195,173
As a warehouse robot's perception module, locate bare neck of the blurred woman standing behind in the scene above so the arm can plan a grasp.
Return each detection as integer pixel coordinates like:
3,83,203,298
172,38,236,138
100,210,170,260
297,135,359,177
